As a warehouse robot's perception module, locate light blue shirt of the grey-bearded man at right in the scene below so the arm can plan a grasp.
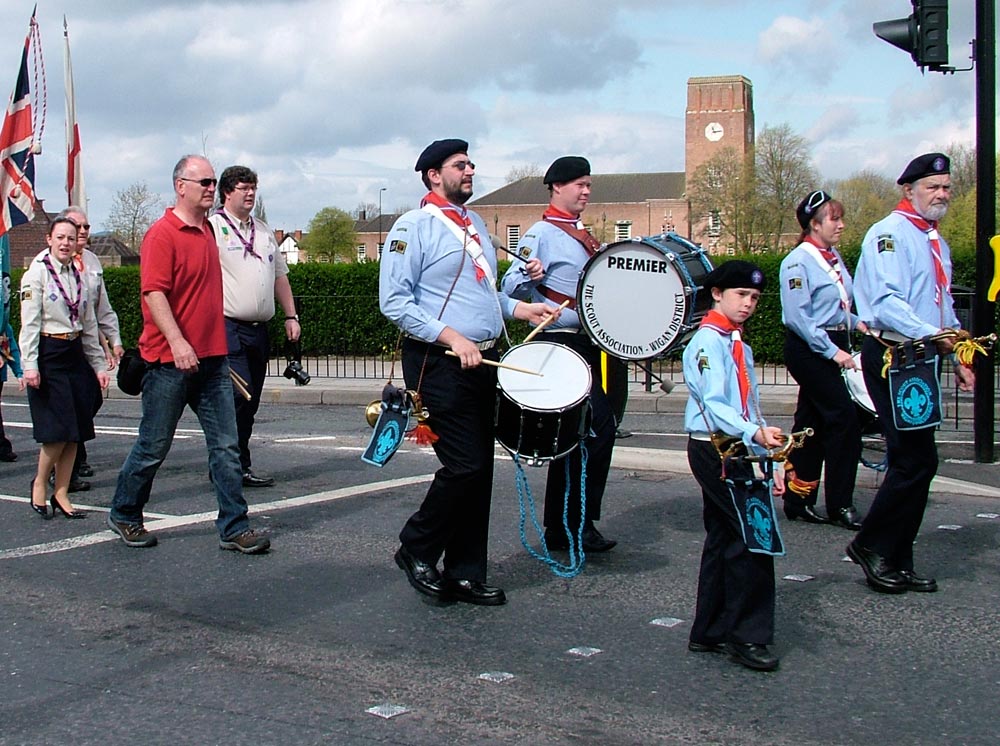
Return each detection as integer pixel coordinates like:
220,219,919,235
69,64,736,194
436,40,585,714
854,213,959,339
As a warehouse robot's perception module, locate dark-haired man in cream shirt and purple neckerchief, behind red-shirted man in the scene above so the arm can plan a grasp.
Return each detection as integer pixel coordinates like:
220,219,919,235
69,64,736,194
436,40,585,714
209,166,302,487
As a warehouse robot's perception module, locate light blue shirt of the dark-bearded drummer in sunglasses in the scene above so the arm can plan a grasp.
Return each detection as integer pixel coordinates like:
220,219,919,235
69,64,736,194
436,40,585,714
378,205,518,342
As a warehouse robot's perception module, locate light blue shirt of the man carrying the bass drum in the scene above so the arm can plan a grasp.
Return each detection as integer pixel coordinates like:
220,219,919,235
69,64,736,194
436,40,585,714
500,220,590,329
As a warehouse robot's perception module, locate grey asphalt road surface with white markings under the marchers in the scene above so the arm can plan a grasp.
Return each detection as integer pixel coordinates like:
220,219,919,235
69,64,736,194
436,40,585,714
0,399,1000,746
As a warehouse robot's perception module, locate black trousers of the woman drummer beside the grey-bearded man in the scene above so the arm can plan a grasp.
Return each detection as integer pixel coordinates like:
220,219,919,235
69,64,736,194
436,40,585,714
785,331,861,516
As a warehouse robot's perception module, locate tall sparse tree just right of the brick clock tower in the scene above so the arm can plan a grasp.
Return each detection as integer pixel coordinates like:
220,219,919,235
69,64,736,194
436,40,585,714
754,124,819,248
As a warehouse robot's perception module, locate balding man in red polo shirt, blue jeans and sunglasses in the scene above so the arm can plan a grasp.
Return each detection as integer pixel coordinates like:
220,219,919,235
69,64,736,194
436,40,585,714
108,155,271,554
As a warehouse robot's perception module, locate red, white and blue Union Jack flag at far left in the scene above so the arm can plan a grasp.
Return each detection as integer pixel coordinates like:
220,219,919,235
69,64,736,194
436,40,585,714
0,15,35,236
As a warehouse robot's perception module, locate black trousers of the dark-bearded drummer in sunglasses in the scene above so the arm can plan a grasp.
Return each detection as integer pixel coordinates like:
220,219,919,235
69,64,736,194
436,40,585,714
399,339,499,583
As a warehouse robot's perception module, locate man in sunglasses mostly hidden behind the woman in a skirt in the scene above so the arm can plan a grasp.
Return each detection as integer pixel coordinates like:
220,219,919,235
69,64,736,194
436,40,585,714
58,205,125,492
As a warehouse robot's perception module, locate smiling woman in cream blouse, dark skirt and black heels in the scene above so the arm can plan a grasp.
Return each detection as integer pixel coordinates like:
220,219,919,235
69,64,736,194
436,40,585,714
19,217,109,518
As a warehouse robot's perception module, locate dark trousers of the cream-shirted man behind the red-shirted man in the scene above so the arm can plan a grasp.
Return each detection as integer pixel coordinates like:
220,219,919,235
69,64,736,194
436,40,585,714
226,317,271,474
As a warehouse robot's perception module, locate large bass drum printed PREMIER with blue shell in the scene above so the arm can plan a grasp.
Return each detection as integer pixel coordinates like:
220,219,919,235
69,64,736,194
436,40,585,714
577,233,712,360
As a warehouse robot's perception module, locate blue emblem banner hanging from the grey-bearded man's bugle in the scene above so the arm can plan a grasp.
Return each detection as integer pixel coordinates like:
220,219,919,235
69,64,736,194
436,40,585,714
889,340,942,430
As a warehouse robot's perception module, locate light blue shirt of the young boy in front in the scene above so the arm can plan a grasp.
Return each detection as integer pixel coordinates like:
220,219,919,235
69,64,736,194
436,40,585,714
684,326,767,454
